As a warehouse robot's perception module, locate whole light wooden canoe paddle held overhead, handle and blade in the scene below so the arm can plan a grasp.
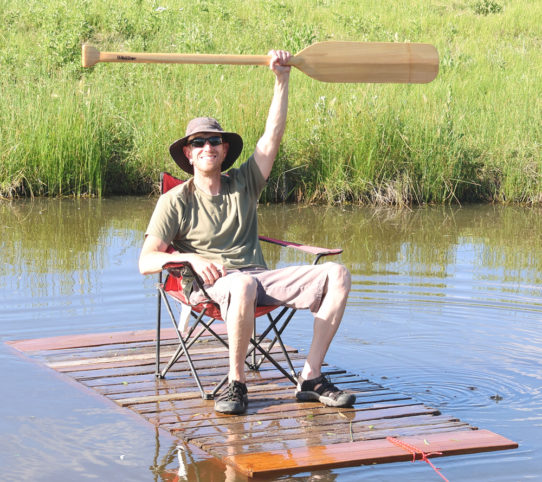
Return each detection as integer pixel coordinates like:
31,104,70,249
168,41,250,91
82,41,438,84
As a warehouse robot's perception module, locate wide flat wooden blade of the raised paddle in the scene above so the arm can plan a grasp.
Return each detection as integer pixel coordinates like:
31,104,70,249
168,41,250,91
290,42,438,84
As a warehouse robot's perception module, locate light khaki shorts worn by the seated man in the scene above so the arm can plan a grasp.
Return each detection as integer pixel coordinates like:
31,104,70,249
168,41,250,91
190,262,336,319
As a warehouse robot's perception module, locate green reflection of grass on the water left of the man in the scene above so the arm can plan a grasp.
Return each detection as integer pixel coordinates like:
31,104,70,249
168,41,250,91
0,198,148,275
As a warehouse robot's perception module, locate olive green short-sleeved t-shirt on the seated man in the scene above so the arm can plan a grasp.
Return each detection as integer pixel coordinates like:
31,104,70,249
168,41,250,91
146,155,266,268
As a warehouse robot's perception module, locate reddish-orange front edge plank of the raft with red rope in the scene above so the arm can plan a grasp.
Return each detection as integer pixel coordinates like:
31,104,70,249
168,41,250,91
223,430,518,477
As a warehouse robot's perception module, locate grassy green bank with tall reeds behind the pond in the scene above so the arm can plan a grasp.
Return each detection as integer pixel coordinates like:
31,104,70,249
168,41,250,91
0,0,542,204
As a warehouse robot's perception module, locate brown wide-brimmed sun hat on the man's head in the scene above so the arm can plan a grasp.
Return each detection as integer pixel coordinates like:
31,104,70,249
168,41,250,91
169,117,243,176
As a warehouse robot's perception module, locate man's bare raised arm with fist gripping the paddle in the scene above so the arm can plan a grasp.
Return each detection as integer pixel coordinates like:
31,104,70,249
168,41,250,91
254,50,291,179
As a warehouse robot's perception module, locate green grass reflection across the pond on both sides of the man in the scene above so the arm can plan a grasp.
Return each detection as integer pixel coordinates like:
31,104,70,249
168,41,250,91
4,198,542,292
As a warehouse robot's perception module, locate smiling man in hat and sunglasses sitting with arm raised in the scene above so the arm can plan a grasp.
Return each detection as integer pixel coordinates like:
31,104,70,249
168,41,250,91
139,51,355,414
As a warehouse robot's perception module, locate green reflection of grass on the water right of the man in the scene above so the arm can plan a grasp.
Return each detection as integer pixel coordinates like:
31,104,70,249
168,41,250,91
260,202,542,285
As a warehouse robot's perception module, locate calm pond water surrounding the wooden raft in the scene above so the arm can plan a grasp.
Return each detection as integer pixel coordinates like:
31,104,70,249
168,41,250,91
0,197,542,481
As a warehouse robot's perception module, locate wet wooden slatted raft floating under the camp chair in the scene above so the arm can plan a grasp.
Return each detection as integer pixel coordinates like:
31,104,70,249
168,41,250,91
8,326,518,476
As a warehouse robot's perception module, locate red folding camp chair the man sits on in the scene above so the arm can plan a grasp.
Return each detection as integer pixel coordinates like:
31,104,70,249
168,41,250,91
156,172,342,400
